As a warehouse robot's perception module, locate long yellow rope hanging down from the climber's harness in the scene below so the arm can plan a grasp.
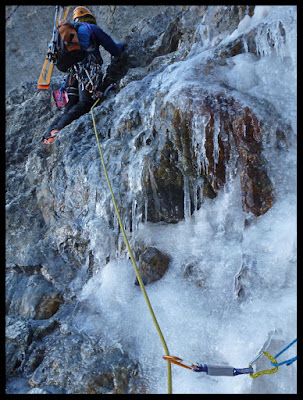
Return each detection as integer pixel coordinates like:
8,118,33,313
91,99,172,394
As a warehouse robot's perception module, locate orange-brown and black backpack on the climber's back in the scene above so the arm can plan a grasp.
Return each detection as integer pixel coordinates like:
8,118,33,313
54,19,87,72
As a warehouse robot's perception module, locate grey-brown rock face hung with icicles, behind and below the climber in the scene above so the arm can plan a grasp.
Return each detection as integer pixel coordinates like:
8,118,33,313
6,6,298,394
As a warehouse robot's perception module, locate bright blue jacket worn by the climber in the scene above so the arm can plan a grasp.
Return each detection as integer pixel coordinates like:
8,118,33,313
75,22,123,64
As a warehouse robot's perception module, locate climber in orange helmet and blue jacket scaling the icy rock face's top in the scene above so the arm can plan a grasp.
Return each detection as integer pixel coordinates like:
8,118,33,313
42,6,126,144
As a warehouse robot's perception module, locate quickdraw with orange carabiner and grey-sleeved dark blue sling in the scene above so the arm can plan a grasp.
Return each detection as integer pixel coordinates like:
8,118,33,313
163,356,254,376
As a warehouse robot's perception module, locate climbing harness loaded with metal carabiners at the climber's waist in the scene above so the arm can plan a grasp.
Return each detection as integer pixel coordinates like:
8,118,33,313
71,54,103,99
